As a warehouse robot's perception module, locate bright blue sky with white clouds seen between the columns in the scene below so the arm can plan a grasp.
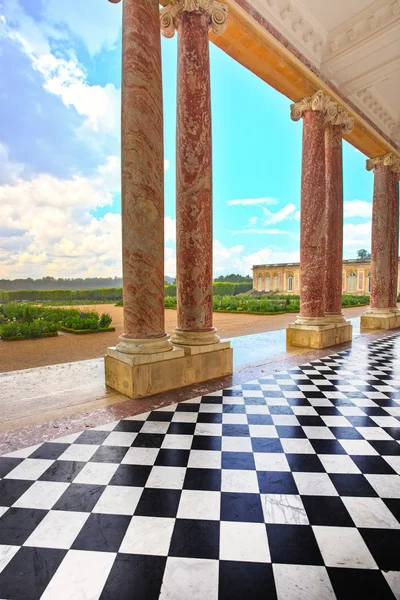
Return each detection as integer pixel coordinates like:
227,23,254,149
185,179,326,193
0,0,373,278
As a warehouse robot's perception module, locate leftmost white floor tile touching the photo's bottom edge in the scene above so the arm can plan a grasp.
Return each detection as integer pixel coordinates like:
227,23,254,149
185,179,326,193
41,550,116,600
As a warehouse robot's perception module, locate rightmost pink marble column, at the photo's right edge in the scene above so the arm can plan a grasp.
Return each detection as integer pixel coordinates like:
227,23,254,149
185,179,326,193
370,162,399,311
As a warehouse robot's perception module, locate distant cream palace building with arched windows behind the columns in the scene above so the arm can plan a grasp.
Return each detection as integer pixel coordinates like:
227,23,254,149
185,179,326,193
253,258,400,296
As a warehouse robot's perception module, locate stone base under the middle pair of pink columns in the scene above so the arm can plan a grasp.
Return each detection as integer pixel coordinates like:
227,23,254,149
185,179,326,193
286,317,353,349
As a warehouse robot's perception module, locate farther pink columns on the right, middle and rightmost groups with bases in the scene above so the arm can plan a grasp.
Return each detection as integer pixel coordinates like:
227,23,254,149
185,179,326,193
287,90,400,348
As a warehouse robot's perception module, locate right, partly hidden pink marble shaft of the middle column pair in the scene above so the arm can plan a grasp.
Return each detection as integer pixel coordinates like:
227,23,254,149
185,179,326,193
324,124,343,319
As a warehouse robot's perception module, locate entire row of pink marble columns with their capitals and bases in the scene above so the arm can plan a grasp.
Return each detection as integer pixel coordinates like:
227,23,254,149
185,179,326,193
106,0,398,397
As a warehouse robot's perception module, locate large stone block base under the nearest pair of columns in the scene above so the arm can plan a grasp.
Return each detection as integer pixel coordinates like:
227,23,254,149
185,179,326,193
105,342,233,398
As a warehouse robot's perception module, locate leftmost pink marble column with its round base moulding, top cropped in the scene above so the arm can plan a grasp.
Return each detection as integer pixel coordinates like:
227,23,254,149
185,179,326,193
113,0,172,354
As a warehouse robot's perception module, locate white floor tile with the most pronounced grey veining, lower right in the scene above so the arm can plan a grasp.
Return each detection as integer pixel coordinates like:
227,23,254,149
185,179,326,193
261,494,308,525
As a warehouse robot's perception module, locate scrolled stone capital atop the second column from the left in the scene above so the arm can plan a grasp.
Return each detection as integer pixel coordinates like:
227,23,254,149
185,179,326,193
160,0,228,38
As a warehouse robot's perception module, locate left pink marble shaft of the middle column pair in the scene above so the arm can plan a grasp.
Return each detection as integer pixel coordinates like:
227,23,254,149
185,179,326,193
298,110,326,321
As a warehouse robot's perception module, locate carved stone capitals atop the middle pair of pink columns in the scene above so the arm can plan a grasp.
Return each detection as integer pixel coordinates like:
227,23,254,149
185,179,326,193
290,90,354,133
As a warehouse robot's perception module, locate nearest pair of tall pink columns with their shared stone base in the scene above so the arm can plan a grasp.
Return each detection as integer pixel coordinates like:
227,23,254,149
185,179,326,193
105,0,233,397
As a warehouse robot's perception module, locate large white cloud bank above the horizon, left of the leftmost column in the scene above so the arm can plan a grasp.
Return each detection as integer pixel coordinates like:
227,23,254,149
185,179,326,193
0,156,121,279
